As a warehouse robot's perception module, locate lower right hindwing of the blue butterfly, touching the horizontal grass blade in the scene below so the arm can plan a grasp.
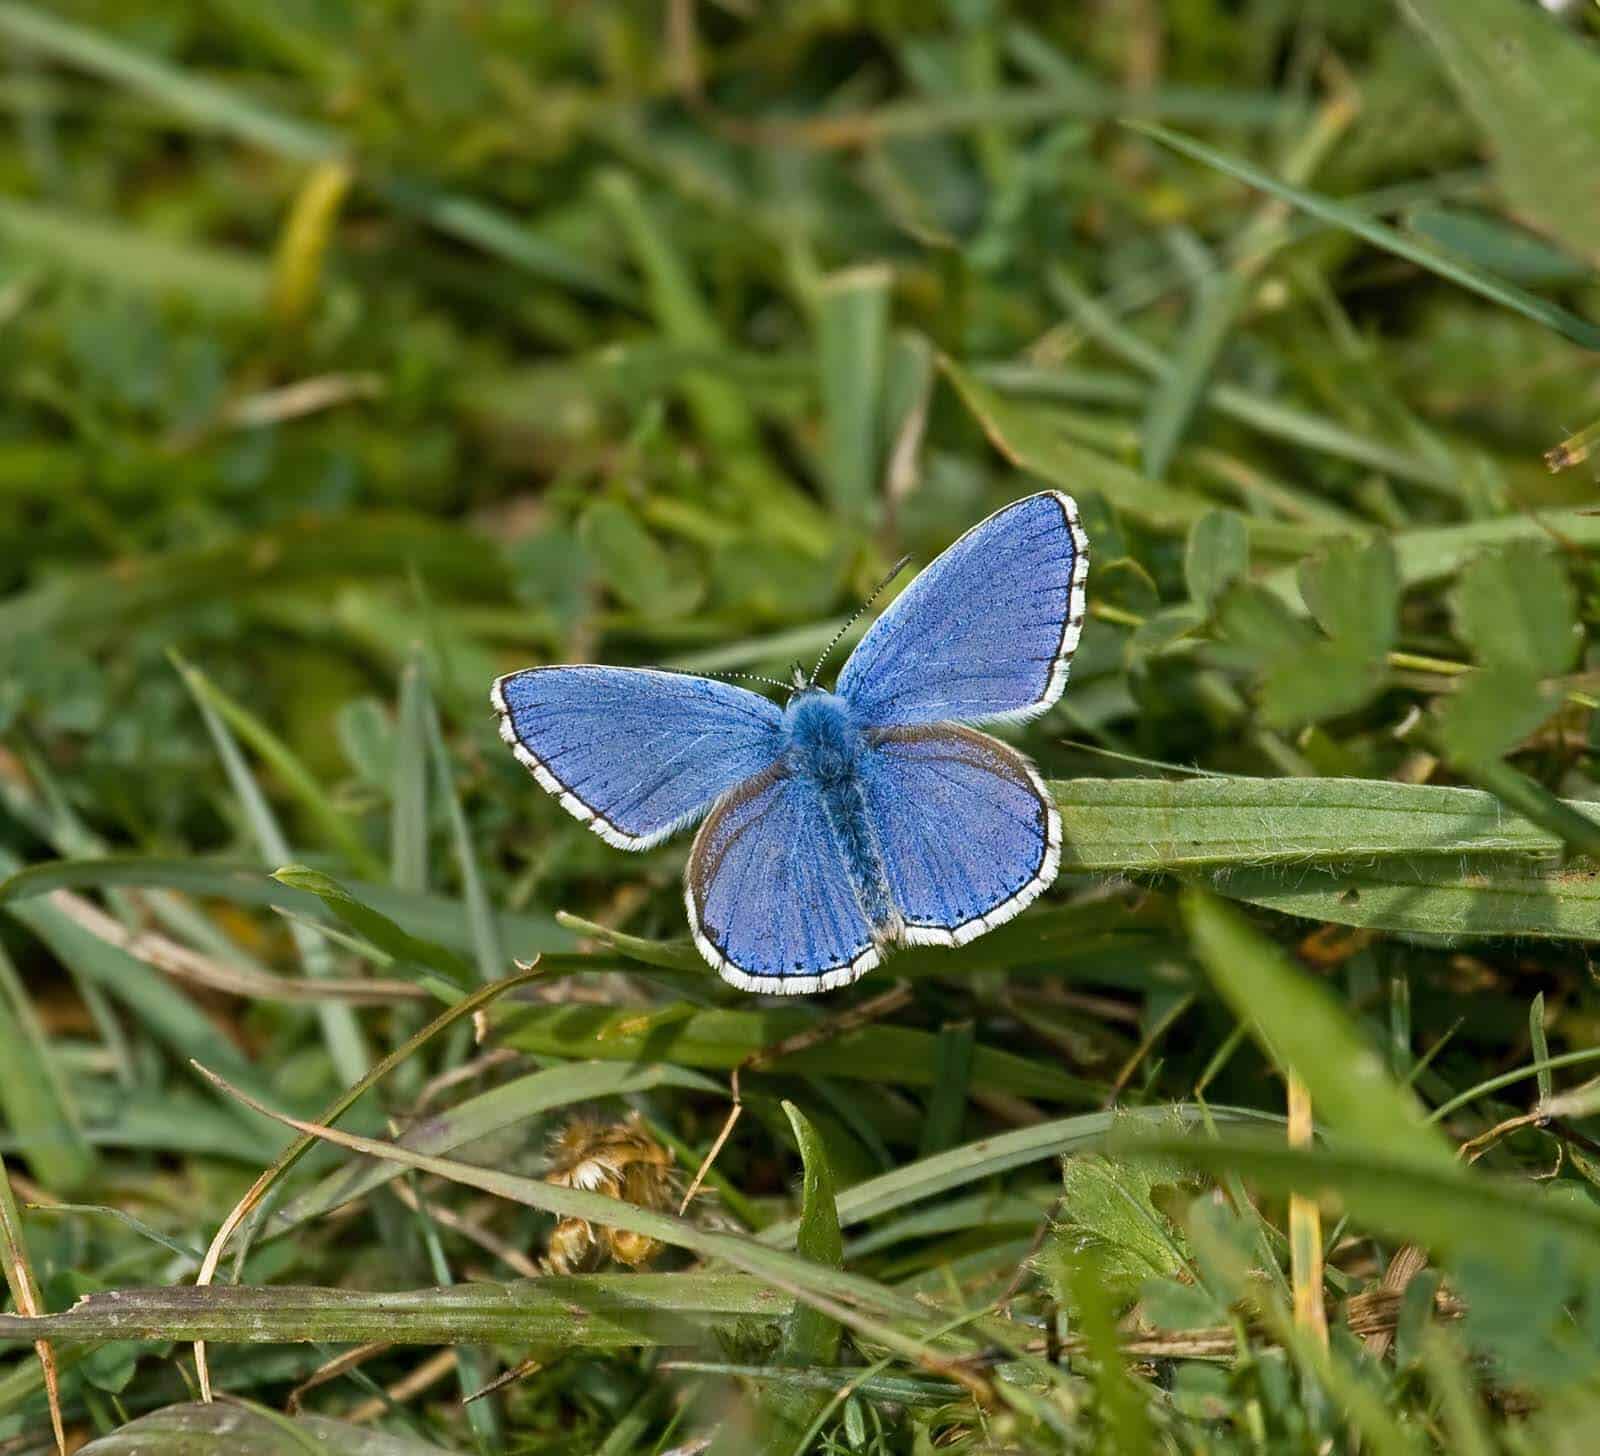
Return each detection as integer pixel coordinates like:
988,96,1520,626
862,723,1061,946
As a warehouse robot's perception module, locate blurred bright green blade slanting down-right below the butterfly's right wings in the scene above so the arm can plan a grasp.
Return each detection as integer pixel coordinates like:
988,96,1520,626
1182,890,1454,1166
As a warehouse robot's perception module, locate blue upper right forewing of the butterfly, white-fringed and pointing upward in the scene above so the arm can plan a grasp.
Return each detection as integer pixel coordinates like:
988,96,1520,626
837,491,1088,726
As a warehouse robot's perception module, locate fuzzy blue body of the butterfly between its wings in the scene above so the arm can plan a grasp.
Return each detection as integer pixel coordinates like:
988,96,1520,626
784,690,901,942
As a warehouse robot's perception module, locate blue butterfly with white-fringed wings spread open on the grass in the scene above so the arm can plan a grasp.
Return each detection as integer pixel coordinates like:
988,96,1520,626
493,491,1088,994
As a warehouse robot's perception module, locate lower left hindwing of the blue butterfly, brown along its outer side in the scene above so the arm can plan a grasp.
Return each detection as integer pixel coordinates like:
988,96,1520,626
685,765,880,994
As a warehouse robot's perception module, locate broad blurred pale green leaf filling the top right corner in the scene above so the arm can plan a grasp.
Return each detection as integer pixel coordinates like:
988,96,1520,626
1402,0,1600,264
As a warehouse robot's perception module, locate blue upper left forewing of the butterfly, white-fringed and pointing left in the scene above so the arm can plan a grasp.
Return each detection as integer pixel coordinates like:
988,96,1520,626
493,666,782,850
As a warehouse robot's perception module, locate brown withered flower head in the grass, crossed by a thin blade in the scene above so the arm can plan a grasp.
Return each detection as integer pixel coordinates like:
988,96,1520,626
544,1112,677,1274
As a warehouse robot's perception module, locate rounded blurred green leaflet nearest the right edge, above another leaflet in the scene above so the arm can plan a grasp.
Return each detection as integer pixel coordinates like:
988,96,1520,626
1450,541,1578,678
